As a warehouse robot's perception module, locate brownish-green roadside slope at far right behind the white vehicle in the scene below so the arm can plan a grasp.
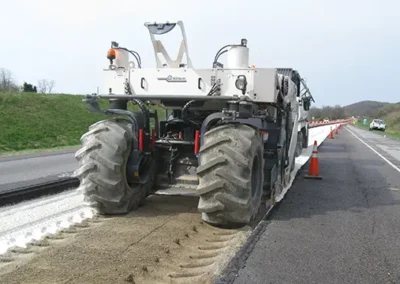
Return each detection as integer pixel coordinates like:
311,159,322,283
356,104,400,139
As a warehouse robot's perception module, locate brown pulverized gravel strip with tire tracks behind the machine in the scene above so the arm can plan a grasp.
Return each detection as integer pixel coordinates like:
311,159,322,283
0,196,251,284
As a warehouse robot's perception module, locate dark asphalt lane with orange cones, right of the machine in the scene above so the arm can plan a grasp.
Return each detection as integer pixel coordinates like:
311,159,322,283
225,127,400,284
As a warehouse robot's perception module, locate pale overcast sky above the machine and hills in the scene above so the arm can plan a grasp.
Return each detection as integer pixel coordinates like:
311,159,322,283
0,0,400,106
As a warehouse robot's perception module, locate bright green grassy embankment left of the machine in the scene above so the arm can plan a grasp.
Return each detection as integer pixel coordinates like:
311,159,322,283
0,93,165,155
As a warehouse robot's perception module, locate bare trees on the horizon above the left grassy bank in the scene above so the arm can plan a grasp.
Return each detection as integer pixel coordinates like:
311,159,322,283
0,68,56,94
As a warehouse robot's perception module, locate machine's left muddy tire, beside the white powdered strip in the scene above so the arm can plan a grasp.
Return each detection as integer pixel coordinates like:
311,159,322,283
75,119,154,214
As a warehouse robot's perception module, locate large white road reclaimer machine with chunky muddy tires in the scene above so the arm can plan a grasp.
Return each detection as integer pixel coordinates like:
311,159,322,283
75,21,313,226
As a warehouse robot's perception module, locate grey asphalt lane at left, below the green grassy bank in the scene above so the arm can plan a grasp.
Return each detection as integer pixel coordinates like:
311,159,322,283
0,150,78,192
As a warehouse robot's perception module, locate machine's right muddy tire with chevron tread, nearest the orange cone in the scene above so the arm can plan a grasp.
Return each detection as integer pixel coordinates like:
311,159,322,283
197,124,264,226
